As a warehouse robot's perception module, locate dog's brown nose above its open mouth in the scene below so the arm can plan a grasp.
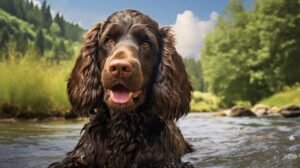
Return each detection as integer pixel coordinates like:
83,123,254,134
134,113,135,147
108,59,132,78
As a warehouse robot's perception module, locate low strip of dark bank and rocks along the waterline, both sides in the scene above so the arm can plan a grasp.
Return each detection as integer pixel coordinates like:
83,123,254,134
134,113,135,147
0,104,300,122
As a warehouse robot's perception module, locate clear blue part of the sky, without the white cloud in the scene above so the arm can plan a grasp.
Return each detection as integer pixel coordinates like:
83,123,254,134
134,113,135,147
40,0,228,28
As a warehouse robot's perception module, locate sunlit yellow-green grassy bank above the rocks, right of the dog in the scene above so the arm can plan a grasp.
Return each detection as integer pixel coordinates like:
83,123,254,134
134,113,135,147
191,84,300,116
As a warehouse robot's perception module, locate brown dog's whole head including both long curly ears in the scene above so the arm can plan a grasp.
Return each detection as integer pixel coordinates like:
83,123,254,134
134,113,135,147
68,10,191,120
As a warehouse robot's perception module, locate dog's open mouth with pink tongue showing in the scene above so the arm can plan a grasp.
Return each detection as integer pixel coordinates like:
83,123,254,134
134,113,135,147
107,84,142,104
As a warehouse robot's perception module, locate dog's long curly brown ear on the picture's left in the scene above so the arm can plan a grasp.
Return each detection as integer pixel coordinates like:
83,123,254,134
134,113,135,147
67,23,102,117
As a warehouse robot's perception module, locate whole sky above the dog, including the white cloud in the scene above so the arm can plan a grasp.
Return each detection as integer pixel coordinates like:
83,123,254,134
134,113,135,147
31,0,254,59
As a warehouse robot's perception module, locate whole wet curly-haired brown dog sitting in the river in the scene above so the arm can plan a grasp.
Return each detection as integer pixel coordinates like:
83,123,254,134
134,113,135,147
49,10,193,168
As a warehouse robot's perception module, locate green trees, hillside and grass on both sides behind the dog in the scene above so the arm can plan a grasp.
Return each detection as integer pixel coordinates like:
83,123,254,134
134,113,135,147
0,0,300,118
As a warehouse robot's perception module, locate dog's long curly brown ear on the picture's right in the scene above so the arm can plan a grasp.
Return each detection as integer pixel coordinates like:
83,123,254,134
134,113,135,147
153,27,192,120
